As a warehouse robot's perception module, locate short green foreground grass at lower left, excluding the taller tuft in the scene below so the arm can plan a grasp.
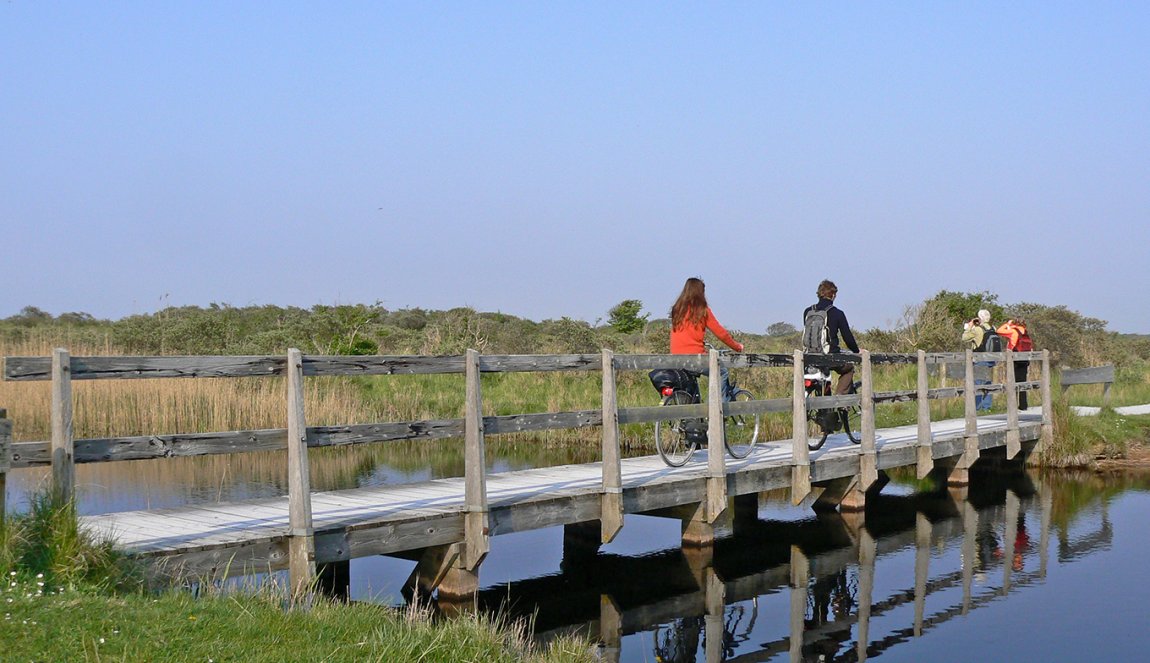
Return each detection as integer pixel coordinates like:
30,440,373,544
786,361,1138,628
0,580,592,663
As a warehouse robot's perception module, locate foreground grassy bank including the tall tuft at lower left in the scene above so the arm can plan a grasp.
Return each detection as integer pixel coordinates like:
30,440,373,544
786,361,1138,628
0,496,592,663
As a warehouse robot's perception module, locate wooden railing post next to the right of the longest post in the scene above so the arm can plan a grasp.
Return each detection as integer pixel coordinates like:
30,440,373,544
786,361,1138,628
460,349,491,572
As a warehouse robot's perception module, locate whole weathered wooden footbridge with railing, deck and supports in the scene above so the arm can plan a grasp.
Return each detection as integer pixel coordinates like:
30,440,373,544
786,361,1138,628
0,349,1052,600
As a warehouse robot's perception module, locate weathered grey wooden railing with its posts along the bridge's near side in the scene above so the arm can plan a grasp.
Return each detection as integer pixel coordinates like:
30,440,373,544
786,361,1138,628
0,349,1051,580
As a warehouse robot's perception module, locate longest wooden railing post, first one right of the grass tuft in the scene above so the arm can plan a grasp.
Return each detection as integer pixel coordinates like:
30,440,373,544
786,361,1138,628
281,348,315,598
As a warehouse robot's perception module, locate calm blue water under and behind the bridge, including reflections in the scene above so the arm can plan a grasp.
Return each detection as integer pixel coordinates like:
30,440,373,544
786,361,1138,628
9,446,1150,662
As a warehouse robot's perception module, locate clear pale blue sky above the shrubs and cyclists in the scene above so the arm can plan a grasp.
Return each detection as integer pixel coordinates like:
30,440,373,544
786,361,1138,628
0,0,1150,333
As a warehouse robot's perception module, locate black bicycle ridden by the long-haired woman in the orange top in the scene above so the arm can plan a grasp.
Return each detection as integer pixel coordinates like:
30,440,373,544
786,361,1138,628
650,356,759,468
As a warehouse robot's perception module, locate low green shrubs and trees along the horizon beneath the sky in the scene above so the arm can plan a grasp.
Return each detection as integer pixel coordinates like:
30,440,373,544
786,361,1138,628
0,291,1150,367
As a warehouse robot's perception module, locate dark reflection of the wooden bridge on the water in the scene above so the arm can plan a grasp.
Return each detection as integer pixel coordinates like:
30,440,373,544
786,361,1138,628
464,475,1113,663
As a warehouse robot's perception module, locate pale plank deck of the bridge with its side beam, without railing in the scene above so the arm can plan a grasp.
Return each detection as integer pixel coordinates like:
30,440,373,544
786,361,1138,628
82,413,1041,569
